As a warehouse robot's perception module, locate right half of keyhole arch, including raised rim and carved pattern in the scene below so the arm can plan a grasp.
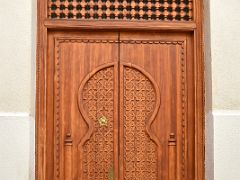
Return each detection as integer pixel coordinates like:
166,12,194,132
119,62,160,180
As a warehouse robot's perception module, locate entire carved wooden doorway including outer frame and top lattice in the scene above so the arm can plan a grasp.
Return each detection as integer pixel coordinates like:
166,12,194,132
36,0,204,180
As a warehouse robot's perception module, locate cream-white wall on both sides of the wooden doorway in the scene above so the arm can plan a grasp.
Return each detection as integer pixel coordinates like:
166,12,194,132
0,0,240,180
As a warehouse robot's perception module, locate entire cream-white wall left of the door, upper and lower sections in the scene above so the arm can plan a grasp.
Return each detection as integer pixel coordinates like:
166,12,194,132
0,0,36,180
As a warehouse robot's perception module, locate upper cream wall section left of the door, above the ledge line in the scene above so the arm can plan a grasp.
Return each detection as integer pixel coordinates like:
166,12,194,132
0,0,32,112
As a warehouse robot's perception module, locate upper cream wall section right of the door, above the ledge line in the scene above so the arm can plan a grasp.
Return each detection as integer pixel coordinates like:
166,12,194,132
210,0,240,110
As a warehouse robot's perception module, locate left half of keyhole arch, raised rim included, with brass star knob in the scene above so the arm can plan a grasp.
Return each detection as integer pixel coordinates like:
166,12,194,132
78,63,118,180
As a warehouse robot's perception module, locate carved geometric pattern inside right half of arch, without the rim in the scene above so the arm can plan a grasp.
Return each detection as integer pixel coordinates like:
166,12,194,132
123,67,158,180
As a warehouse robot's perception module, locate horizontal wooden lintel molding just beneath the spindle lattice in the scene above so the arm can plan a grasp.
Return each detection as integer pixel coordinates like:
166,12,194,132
44,19,196,32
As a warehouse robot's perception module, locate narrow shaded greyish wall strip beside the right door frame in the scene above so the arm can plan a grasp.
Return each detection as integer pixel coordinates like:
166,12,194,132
204,0,214,180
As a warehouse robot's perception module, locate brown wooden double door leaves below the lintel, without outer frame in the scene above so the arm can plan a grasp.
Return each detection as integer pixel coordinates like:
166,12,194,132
46,31,195,180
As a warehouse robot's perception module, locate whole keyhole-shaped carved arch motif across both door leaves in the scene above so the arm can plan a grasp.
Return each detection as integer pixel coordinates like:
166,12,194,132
78,63,160,180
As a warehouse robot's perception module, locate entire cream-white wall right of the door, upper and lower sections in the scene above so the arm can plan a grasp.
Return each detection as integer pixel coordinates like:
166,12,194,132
209,0,240,180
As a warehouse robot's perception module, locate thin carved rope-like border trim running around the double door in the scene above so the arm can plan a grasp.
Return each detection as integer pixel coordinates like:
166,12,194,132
54,37,186,180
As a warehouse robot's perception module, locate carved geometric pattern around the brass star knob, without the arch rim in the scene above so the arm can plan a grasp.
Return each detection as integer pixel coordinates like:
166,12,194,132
82,67,114,180
